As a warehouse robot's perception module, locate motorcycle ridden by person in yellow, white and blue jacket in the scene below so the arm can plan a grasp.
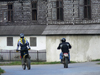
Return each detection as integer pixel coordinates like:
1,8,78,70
16,50,31,70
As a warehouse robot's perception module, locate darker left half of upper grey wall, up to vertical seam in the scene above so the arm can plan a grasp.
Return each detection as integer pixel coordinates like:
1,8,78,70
0,0,47,25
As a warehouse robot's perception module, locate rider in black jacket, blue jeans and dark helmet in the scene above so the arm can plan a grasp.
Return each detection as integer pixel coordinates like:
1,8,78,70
57,38,72,63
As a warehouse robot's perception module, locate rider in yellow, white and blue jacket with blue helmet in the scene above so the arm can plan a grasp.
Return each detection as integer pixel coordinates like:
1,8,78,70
16,33,30,64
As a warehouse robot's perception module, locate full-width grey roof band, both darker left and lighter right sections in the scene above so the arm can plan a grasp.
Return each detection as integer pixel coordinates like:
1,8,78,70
0,24,100,36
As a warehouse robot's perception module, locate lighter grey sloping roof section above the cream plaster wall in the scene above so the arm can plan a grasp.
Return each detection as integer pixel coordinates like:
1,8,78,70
42,24,100,35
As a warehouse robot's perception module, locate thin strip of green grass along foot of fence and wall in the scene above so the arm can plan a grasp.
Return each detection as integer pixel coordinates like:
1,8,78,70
0,61,76,66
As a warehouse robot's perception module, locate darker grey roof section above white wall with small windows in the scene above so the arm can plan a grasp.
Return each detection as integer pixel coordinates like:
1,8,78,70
0,25,46,36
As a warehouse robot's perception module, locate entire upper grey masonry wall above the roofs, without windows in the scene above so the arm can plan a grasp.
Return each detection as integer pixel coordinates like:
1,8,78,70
0,0,100,25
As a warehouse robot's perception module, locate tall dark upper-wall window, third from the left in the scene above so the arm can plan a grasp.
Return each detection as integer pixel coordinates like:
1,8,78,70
56,0,63,20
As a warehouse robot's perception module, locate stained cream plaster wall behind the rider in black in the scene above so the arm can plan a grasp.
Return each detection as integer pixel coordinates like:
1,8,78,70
46,35,100,62
